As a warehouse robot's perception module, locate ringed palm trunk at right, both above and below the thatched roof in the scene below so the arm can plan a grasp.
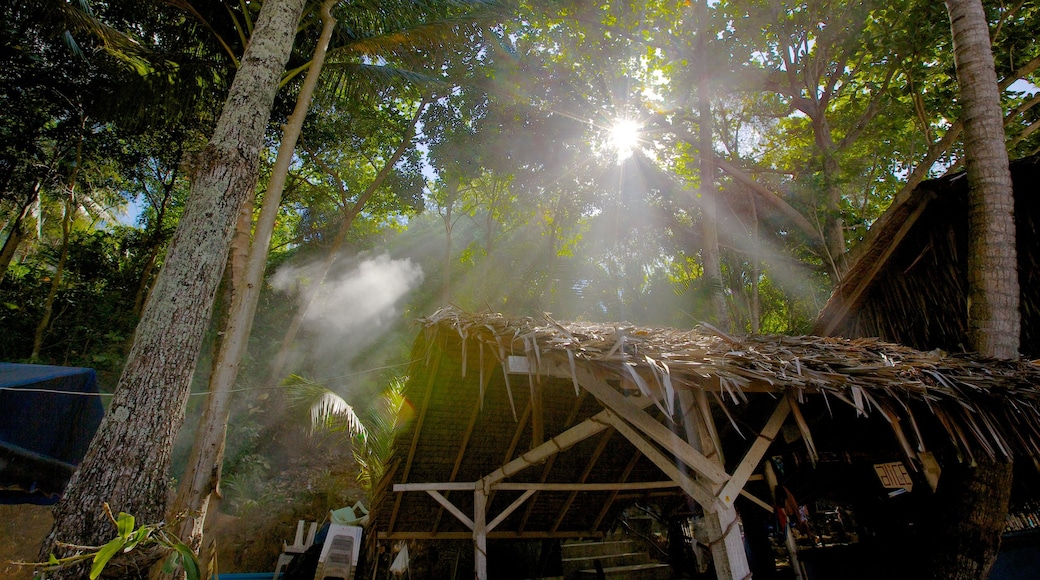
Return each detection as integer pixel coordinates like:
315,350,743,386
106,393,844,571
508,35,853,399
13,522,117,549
929,0,1021,579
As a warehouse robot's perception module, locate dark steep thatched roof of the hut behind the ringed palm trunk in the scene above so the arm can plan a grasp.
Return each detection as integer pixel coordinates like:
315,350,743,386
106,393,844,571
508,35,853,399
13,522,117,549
811,155,1040,357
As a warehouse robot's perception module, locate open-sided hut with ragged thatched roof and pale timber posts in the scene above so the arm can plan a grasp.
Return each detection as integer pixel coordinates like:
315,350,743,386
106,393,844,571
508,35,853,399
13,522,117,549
362,308,1040,579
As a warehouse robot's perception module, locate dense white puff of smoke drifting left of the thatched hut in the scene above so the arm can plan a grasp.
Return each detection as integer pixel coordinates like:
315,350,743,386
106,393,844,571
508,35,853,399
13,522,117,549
270,254,423,374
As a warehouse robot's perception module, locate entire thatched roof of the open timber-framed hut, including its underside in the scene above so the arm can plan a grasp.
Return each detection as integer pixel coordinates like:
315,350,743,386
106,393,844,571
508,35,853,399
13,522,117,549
369,308,1040,552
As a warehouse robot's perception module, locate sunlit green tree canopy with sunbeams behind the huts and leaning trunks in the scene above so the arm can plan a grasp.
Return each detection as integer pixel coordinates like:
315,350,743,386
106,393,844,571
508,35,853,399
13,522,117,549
0,0,1040,577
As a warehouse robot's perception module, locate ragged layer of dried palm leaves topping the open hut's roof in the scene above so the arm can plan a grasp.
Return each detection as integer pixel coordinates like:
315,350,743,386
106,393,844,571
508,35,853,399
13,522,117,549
421,307,1040,462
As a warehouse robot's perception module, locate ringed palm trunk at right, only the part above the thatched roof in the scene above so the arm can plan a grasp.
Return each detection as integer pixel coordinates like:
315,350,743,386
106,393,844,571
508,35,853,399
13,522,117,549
946,0,1021,359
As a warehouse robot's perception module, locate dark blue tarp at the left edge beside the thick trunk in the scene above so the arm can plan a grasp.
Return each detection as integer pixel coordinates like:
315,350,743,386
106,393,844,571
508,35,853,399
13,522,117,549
0,363,104,505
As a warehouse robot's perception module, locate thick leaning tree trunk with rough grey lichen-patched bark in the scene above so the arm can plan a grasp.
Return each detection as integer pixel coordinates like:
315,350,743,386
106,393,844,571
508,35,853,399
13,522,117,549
41,0,304,578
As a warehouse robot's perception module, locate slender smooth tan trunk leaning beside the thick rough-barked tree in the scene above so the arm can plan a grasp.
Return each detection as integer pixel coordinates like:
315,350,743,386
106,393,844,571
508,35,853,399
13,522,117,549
170,0,336,552
